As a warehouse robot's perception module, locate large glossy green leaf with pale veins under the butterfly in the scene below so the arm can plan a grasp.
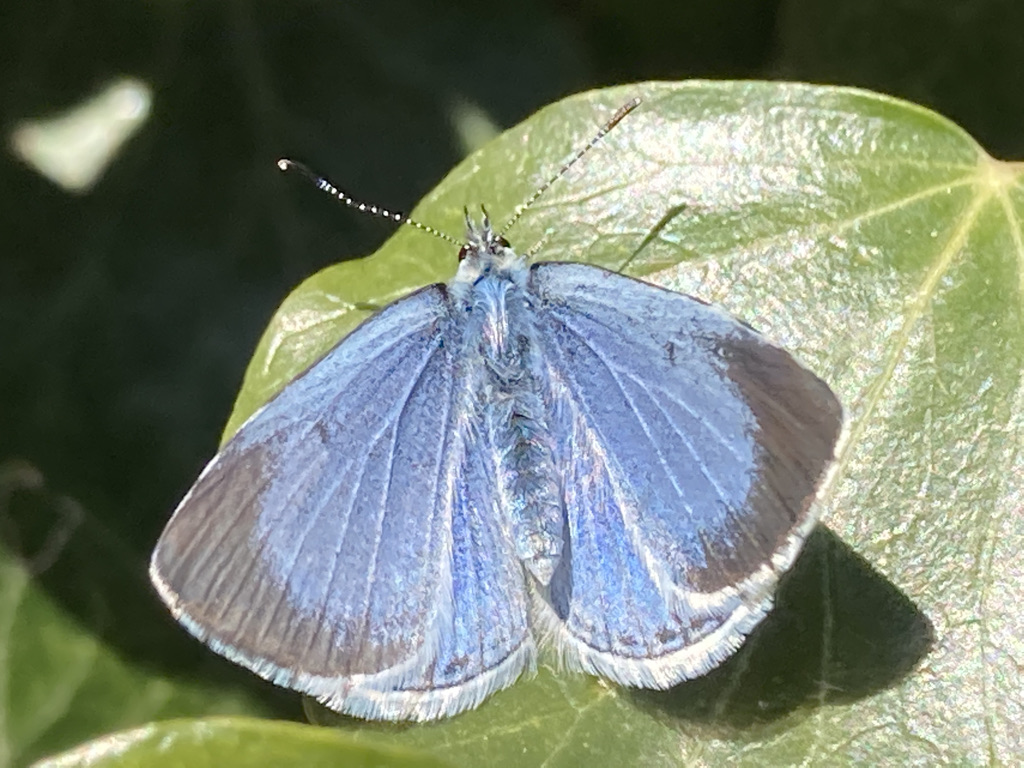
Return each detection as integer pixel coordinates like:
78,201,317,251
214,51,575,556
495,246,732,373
14,82,1024,768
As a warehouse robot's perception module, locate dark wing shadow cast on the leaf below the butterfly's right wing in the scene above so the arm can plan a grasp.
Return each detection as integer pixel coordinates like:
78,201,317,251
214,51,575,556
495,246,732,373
631,525,934,728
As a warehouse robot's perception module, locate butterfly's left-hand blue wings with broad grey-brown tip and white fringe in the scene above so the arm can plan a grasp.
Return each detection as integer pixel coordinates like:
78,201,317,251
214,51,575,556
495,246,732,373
151,286,534,719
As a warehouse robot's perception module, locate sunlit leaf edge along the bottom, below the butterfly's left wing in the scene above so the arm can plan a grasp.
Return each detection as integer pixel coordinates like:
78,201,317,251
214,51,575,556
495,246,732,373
37,718,444,768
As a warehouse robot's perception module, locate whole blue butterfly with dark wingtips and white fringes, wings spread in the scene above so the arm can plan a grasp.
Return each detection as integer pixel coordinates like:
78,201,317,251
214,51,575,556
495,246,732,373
151,103,843,720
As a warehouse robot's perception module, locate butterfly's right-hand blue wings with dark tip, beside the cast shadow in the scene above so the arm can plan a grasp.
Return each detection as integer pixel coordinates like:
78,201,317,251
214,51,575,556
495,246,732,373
530,263,842,688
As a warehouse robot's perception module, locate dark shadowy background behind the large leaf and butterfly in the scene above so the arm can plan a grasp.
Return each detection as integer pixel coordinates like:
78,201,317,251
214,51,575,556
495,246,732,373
0,0,1024,765
